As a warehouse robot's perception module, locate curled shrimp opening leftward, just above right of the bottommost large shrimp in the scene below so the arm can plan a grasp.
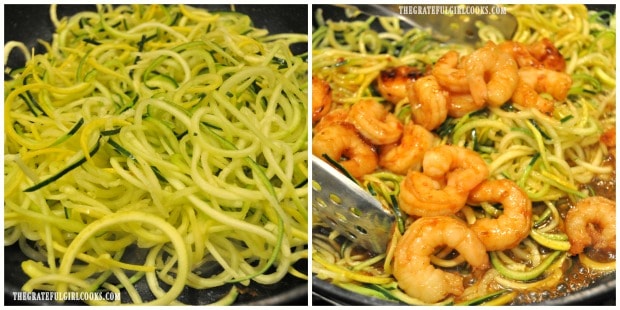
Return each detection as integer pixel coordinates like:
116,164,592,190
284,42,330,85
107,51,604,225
469,179,532,251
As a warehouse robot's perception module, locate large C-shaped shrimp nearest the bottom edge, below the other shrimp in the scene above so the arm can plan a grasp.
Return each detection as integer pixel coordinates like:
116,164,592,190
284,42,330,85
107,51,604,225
394,216,490,303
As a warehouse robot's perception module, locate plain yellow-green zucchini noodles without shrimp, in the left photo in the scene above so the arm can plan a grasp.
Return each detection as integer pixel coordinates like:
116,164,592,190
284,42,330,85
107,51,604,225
4,5,308,305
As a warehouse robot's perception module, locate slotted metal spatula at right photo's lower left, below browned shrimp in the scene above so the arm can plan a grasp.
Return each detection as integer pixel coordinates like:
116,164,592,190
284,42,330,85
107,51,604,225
312,155,395,253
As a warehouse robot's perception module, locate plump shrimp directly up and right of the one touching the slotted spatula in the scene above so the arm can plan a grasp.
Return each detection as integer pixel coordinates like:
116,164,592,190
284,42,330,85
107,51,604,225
348,99,403,145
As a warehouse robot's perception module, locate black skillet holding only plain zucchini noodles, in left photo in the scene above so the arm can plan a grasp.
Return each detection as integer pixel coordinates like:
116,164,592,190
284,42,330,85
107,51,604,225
4,5,309,305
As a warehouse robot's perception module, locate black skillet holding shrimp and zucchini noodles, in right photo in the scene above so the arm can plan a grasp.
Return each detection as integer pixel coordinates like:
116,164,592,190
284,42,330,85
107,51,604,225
312,5,616,306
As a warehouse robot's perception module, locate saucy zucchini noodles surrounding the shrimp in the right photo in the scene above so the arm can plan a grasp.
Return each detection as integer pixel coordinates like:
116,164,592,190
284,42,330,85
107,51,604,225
312,5,616,305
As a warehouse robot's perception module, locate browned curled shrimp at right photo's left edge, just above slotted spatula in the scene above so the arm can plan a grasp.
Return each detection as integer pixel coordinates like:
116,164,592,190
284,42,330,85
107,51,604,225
312,123,379,178
